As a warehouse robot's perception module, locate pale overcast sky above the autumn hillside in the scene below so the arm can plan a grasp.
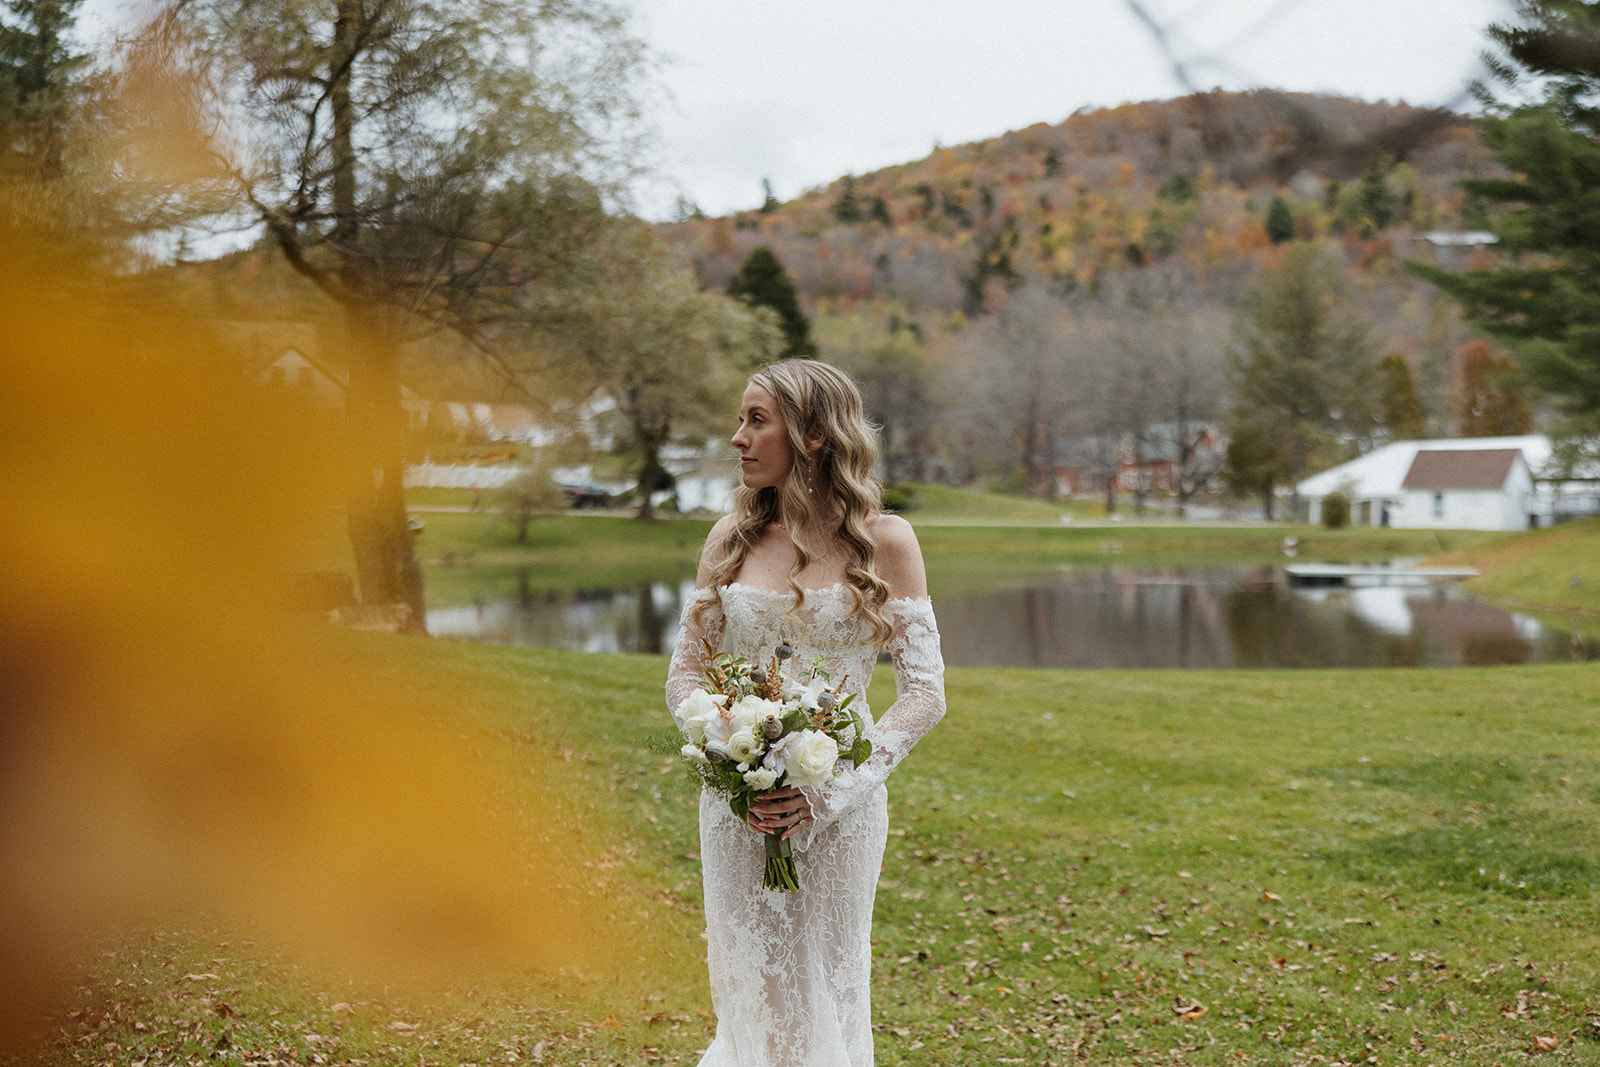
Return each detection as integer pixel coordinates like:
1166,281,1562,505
632,0,1514,218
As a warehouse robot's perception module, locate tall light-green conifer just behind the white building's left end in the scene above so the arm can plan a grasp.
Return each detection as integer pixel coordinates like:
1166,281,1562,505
1230,243,1376,518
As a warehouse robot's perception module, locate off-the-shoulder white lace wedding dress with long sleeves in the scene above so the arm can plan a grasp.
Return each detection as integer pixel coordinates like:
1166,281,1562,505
667,582,944,1067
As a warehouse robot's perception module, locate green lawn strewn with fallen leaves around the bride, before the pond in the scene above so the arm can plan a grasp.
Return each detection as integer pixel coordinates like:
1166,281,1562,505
40,635,1600,1067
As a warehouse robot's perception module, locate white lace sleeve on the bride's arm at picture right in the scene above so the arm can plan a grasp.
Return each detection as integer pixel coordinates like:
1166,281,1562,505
795,600,944,848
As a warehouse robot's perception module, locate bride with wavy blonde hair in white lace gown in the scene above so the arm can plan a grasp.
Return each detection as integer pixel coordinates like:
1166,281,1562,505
667,360,944,1067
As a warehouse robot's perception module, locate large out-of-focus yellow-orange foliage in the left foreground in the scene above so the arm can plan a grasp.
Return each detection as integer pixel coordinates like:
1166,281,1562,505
0,227,617,1056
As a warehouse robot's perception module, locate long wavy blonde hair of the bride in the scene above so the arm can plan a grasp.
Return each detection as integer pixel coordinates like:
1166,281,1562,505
696,360,893,645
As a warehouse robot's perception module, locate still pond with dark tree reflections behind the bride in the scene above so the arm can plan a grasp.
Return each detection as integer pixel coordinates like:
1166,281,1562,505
427,566,1600,669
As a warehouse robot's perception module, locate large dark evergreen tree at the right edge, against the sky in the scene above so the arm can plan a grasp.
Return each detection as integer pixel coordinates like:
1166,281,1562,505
1411,0,1600,429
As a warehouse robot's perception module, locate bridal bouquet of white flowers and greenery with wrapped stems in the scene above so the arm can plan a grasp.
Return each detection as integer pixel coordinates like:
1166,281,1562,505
677,641,872,893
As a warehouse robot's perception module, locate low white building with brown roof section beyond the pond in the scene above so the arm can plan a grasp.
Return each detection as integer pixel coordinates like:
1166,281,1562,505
1296,434,1554,530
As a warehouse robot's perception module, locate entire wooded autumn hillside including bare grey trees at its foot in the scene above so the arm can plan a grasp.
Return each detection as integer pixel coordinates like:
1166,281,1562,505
661,91,1498,495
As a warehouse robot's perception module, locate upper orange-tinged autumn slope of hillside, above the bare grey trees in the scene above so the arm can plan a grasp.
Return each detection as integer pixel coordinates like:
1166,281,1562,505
662,91,1491,314
